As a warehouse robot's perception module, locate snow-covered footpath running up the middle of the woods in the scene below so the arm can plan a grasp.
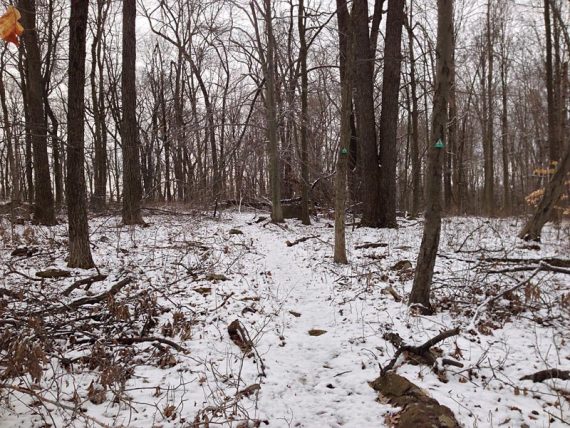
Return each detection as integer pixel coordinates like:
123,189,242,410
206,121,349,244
248,224,386,427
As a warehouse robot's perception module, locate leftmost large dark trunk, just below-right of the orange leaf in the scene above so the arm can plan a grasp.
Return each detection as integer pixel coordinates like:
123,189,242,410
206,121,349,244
19,0,57,226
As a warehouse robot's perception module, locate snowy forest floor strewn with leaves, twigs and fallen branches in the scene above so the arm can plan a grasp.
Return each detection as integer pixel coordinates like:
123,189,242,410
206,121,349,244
0,211,570,428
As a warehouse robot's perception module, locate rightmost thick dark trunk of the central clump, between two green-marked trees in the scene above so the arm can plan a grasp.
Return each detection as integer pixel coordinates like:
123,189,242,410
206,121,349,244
380,0,405,227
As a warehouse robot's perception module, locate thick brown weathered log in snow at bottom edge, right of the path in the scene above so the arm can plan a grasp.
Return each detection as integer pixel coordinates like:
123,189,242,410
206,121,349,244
370,373,460,428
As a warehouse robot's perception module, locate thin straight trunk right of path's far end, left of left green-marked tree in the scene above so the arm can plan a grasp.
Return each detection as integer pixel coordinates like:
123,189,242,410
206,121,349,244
298,0,311,225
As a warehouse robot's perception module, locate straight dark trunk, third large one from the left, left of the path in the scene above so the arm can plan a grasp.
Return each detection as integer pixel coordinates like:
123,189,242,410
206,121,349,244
121,0,144,224
